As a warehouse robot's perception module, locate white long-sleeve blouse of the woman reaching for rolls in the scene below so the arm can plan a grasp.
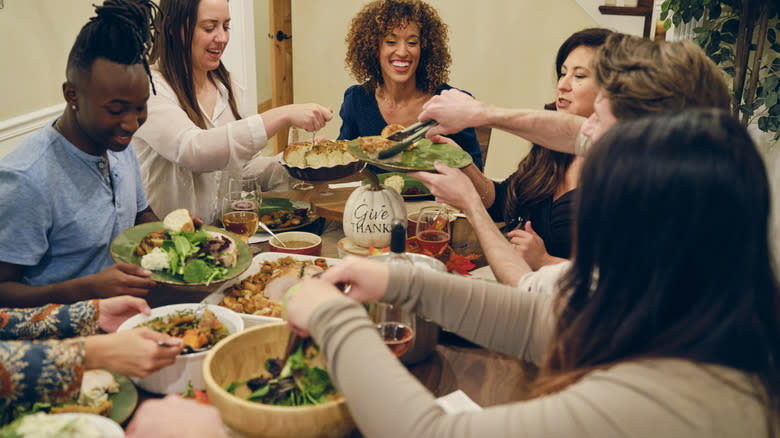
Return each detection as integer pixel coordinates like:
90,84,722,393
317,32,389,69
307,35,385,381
133,69,284,223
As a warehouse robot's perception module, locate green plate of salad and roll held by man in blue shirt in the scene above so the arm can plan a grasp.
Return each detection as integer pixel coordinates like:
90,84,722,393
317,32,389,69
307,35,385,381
110,209,252,292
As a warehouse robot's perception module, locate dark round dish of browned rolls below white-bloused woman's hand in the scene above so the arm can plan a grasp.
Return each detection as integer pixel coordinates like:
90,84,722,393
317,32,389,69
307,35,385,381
281,140,363,181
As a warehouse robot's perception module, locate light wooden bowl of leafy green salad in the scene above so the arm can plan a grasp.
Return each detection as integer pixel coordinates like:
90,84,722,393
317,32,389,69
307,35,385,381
203,322,355,438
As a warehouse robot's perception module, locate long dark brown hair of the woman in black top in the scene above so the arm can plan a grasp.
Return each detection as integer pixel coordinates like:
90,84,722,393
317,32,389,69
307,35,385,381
504,28,612,226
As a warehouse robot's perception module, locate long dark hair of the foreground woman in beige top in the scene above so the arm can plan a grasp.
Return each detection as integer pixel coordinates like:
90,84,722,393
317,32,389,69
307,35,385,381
538,110,780,430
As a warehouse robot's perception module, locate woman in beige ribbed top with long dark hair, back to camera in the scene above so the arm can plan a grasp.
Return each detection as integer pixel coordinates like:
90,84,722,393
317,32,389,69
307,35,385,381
286,110,780,438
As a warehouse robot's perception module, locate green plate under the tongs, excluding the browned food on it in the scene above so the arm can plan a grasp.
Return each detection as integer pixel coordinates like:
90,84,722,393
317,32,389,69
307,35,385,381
349,138,471,172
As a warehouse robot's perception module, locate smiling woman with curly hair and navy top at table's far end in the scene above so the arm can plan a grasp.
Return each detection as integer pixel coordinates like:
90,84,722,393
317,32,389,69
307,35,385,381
339,0,483,169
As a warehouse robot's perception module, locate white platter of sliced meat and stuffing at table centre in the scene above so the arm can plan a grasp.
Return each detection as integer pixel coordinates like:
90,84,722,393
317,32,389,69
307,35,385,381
203,252,340,327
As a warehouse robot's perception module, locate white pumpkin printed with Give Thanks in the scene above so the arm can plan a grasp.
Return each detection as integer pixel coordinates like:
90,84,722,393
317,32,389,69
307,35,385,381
343,184,406,248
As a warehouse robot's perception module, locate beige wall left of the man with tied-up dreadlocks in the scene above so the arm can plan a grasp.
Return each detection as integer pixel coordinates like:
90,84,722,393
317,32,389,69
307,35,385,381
0,0,93,120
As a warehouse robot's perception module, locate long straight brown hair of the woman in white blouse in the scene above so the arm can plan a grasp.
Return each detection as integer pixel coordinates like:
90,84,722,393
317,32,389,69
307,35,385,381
151,0,241,129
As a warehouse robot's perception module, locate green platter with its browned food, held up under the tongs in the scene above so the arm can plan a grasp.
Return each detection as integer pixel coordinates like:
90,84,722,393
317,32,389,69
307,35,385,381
349,136,472,172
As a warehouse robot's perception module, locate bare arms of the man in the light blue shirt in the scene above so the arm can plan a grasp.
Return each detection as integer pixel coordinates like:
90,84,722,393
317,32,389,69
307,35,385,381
0,207,159,307
